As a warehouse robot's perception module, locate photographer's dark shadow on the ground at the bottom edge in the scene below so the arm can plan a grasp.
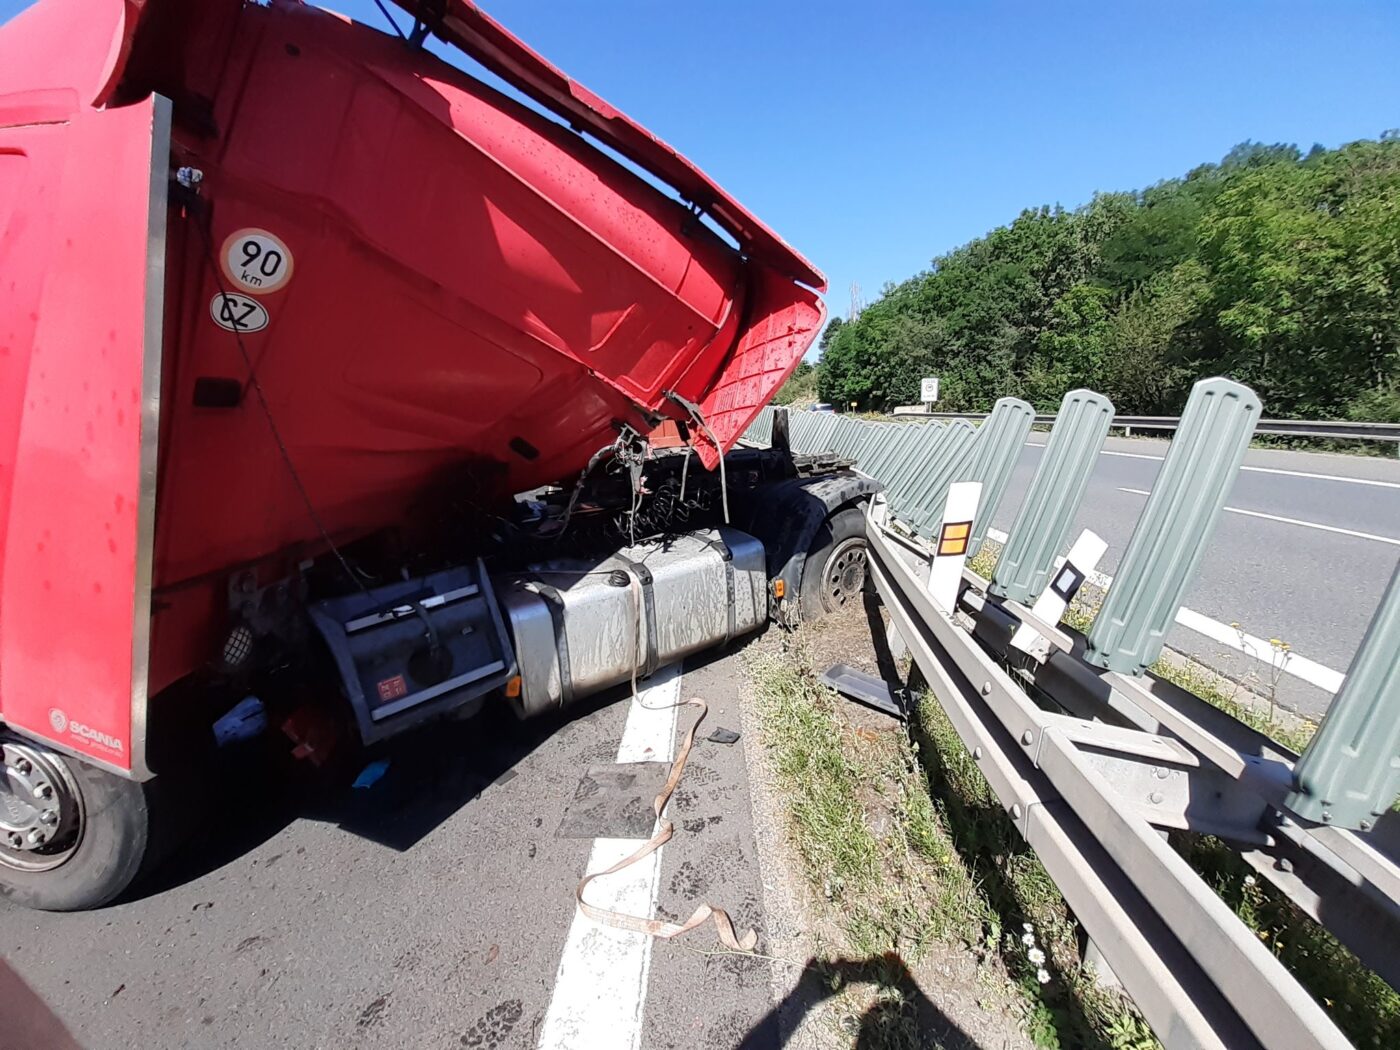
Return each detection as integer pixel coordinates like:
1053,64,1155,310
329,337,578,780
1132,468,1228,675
736,952,977,1050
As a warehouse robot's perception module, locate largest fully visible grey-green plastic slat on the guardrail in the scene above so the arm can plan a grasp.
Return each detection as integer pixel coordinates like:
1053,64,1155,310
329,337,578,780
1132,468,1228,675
1084,377,1260,675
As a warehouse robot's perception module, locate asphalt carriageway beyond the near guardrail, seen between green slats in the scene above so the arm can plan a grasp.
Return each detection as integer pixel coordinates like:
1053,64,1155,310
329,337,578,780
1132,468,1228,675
993,434,1400,718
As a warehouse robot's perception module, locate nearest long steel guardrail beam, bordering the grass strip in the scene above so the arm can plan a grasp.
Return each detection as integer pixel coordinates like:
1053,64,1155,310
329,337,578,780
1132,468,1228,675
868,525,1304,1050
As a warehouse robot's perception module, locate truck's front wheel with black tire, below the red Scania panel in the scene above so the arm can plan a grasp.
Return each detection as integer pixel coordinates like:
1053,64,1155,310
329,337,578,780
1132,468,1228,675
0,735,151,911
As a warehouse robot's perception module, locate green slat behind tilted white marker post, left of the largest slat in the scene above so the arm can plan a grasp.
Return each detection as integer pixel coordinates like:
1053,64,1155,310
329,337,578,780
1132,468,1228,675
988,391,1113,605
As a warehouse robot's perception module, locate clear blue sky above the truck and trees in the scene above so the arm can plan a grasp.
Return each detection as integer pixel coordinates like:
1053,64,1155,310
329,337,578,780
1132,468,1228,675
8,0,1400,341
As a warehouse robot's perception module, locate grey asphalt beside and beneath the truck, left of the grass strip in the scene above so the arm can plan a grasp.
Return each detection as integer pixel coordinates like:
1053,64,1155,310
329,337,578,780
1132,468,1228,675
0,658,778,1050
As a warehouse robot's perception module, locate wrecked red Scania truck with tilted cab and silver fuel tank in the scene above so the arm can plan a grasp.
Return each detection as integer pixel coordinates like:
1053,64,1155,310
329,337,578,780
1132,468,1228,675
0,0,872,909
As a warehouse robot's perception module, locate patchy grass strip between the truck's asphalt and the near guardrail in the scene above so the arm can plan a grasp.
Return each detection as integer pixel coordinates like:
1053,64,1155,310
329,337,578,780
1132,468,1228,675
750,648,1156,1050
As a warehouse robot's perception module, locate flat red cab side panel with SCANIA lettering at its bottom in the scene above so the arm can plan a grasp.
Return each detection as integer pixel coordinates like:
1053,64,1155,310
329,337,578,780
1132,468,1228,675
0,6,164,771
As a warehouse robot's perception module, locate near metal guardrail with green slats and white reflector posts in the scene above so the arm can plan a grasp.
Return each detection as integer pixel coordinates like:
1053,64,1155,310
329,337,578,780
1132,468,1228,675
746,379,1400,1050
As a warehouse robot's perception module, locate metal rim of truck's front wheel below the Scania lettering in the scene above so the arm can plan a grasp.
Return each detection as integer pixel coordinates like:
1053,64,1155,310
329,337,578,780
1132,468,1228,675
0,736,83,871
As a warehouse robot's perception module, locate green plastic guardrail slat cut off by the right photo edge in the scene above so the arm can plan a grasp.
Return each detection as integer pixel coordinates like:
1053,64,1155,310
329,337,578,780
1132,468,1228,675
1284,566,1400,832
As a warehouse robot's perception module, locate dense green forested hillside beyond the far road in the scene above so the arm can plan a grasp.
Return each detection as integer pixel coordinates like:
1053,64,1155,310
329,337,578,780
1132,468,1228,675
817,132,1400,421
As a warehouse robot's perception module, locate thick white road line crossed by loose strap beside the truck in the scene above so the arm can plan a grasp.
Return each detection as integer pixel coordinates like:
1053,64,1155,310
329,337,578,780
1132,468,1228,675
539,664,680,1050
